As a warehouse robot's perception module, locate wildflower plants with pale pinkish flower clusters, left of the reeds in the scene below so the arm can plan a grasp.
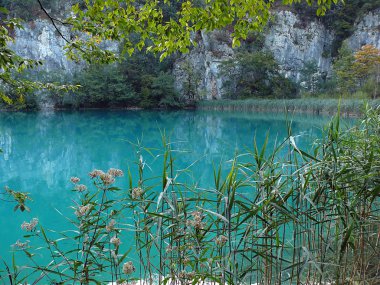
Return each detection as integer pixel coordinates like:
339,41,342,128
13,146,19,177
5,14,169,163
0,168,140,284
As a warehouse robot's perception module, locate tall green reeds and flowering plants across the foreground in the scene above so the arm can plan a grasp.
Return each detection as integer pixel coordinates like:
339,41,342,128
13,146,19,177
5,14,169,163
0,105,380,285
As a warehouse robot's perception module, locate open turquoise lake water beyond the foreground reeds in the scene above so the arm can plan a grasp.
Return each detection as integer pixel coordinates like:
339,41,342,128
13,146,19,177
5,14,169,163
0,111,329,278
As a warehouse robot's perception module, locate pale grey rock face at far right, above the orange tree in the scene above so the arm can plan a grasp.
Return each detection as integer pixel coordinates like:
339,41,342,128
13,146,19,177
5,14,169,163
346,9,380,50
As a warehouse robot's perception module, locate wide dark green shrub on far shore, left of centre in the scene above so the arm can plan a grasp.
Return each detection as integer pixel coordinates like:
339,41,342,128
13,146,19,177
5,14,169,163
63,55,181,108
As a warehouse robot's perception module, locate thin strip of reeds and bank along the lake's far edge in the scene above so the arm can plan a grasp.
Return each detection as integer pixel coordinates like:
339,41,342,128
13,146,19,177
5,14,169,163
0,98,380,117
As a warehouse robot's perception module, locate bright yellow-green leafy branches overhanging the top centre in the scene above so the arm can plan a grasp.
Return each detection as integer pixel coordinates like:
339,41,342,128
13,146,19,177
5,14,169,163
67,0,342,61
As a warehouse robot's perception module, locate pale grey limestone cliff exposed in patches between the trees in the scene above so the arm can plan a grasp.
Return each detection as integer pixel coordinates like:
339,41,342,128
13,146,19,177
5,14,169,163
8,7,380,100
